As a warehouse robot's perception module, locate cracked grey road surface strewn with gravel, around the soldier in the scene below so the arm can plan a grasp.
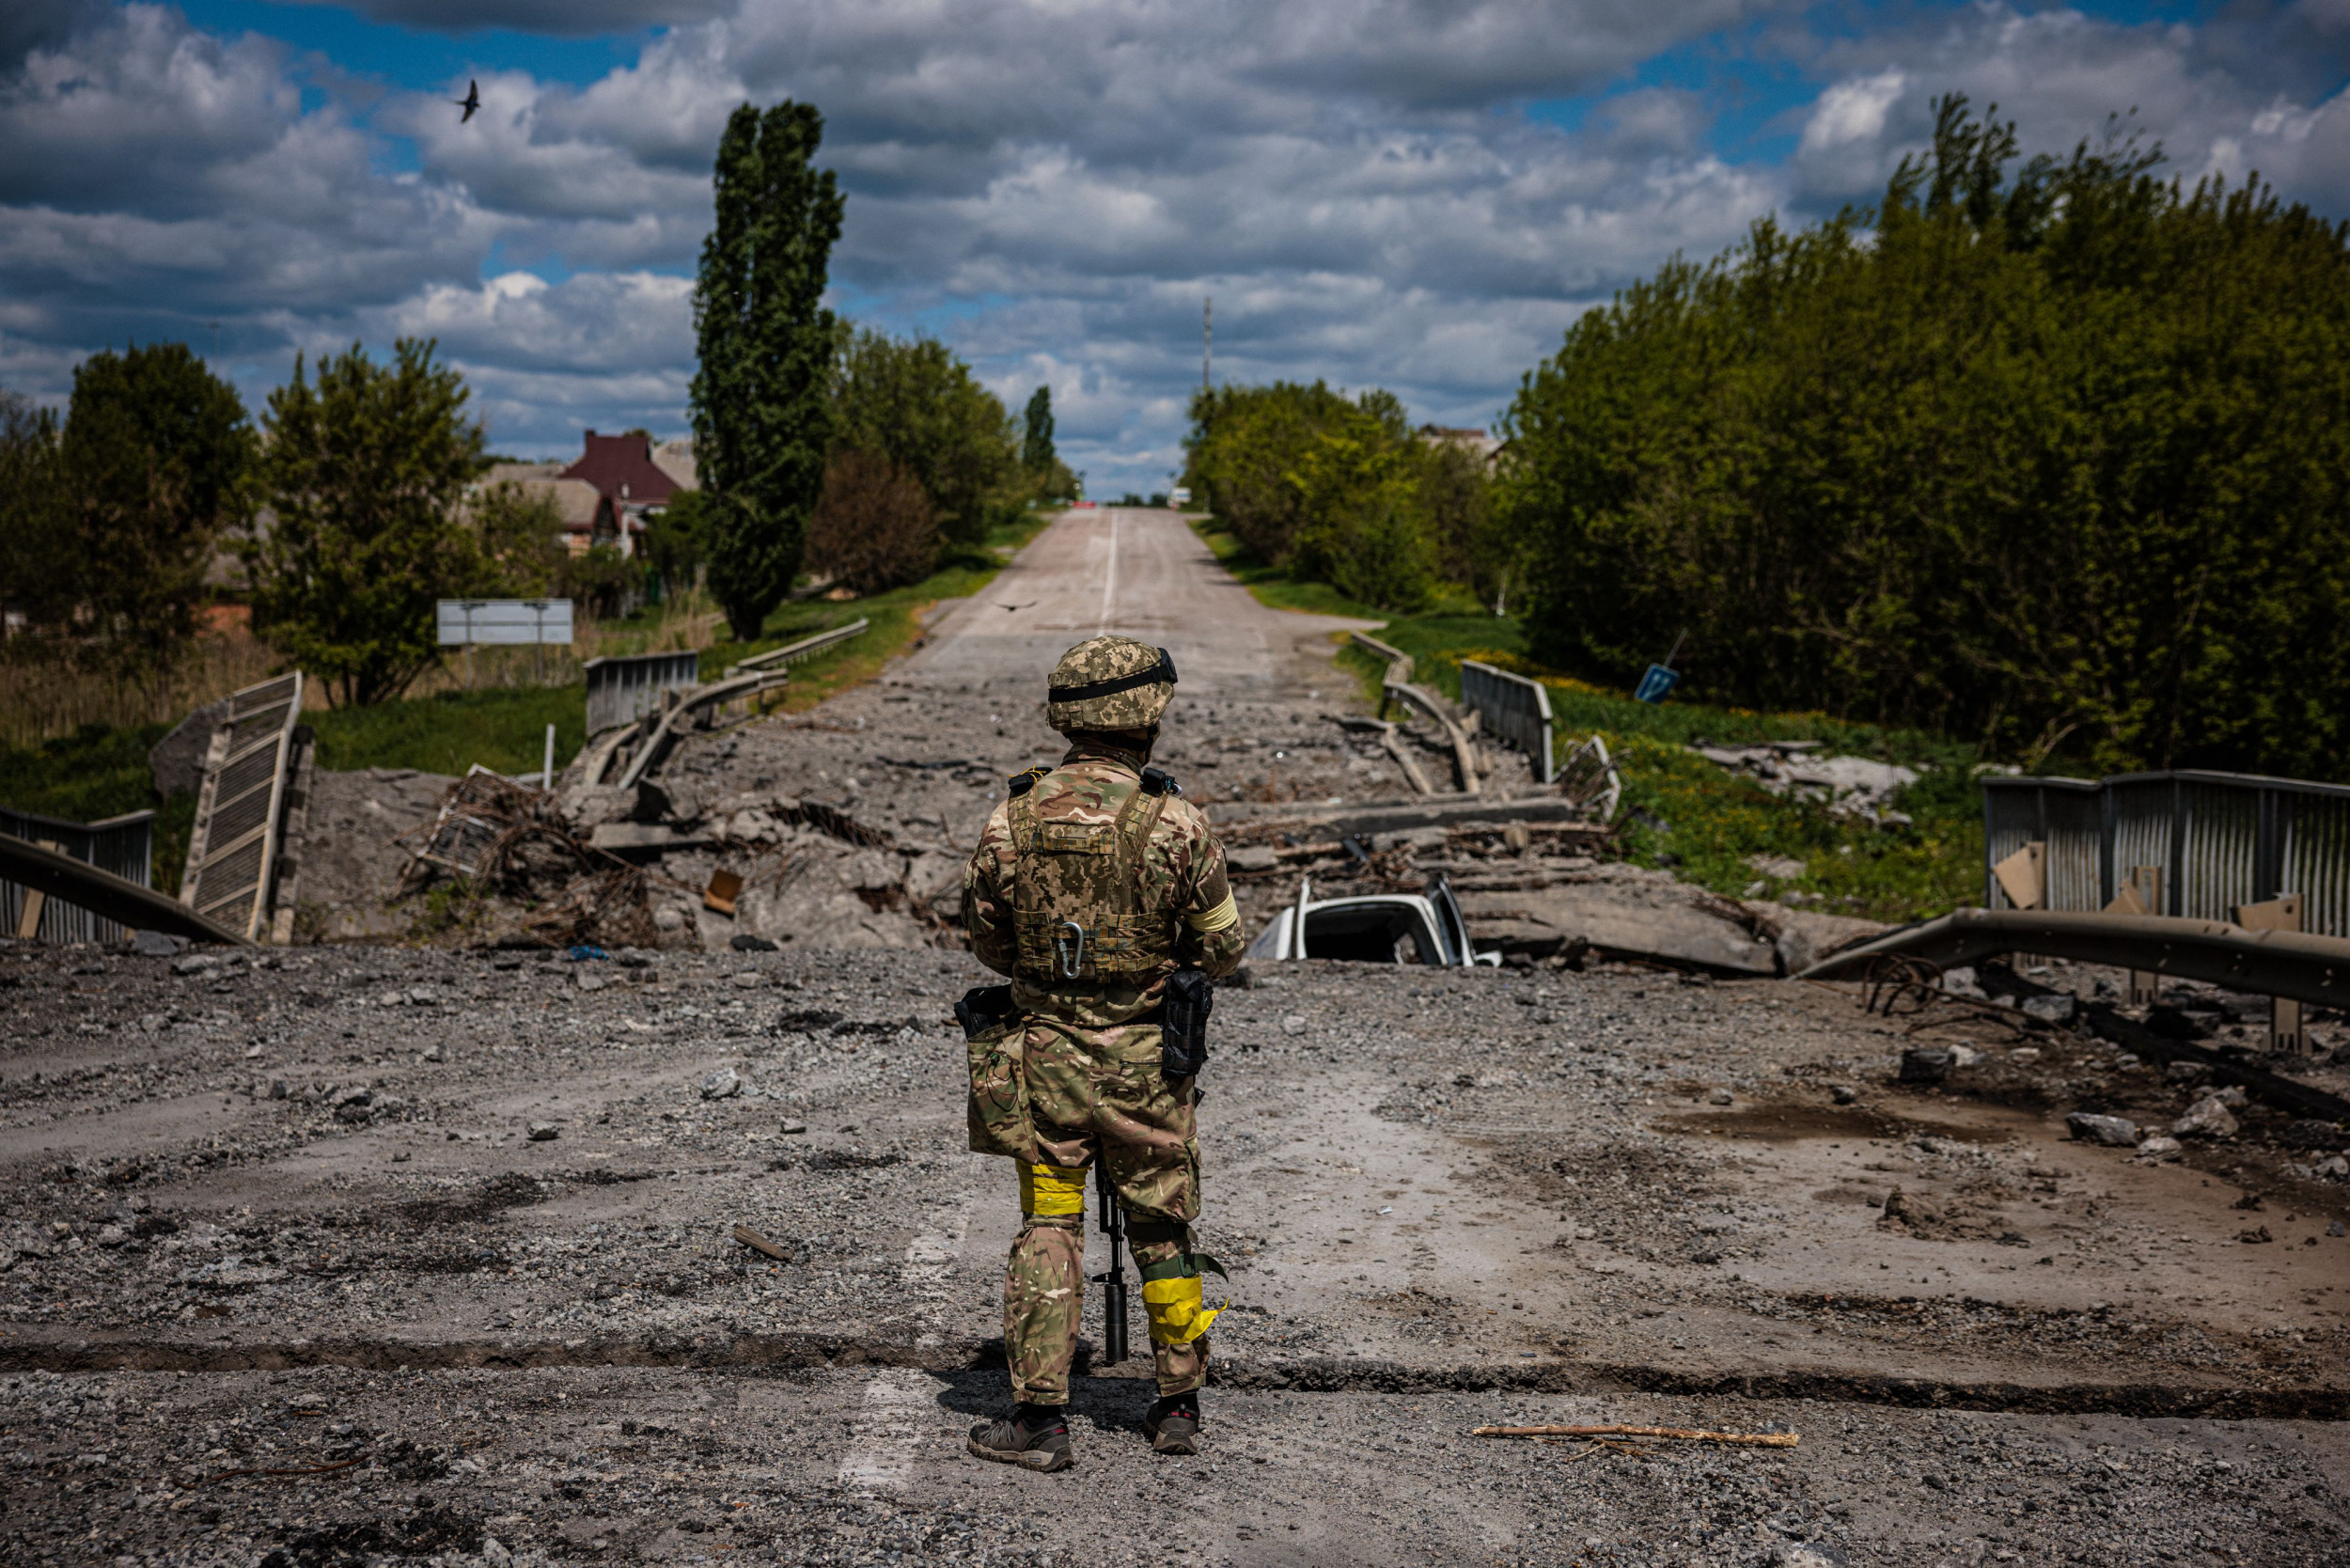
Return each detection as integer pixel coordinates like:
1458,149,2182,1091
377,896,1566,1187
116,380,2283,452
13,512,2350,1568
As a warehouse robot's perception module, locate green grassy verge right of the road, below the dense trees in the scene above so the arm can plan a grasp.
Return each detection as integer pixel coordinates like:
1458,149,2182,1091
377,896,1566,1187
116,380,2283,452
1203,529,1983,921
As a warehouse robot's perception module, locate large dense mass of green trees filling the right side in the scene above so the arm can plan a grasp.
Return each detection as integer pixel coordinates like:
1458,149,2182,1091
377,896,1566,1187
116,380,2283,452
1497,99,2350,778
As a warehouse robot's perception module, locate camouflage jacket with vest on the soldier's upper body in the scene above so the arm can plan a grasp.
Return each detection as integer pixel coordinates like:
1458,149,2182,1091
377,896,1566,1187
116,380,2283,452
964,743,1246,1029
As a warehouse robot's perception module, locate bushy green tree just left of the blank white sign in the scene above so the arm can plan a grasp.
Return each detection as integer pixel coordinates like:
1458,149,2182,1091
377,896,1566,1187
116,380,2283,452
244,338,484,705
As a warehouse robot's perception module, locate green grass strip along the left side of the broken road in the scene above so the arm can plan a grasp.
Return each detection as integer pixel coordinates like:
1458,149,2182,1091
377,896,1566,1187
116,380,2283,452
0,512,1053,891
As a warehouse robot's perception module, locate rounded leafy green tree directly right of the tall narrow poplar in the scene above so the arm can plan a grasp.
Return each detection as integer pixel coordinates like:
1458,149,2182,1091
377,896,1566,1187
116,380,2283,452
835,332,1034,545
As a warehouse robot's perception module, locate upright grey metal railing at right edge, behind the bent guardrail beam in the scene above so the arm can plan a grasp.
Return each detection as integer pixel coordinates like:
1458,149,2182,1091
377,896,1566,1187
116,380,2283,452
1983,769,2350,935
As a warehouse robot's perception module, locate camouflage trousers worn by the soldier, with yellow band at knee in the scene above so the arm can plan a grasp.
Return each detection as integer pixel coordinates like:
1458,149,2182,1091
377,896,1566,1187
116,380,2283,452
1004,1018,1208,1405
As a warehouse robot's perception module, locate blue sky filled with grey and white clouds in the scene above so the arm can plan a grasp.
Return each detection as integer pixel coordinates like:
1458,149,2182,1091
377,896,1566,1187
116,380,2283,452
0,0,2350,494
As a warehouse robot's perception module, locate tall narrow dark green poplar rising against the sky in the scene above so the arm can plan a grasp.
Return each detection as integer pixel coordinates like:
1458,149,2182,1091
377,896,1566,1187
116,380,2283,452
694,99,841,642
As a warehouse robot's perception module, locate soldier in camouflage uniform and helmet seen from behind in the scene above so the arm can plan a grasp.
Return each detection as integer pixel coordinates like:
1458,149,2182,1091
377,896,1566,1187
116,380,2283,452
964,637,1246,1469
